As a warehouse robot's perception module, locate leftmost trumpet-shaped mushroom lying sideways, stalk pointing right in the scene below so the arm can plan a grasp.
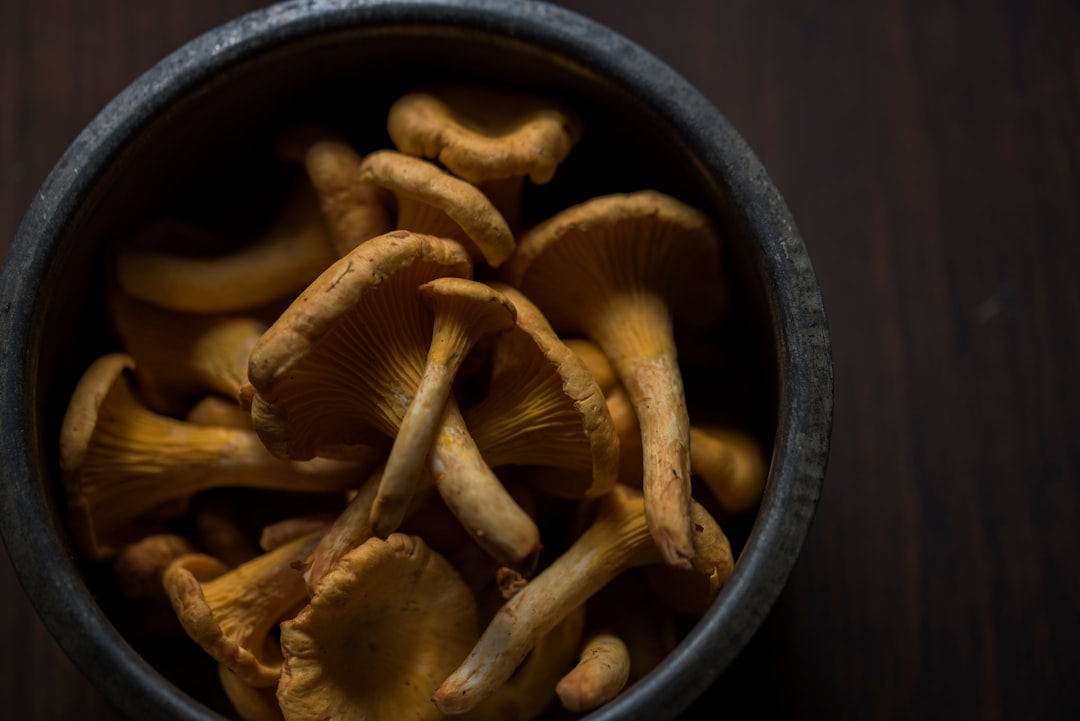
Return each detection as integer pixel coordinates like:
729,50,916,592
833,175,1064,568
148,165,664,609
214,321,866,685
59,353,364,559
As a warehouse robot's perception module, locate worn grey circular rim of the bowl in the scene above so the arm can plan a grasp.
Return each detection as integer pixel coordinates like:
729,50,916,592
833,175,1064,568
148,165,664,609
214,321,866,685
0,0,834,721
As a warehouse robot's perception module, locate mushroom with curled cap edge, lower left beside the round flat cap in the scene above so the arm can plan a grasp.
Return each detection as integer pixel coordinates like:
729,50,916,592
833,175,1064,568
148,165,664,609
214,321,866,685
164,534,318,688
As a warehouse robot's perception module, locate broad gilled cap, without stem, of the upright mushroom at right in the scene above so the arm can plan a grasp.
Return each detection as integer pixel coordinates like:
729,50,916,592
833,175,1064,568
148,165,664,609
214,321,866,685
502,190,727,338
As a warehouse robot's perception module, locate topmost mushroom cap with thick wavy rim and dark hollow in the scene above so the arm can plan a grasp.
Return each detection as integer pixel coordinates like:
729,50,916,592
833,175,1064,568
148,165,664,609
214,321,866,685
387,83,583,183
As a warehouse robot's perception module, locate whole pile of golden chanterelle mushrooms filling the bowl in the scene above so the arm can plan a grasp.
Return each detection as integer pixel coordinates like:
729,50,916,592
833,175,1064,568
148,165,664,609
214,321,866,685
59,84,766,721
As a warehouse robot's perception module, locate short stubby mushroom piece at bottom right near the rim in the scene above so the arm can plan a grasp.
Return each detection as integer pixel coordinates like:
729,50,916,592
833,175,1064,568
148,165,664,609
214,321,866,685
555,631,630,711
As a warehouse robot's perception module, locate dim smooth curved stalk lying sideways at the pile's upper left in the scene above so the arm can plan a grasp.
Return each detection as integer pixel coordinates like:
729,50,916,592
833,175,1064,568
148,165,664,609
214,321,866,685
114,175,338,313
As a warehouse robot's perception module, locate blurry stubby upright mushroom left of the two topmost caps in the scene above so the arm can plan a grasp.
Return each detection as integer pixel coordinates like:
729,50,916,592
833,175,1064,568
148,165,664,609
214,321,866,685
274,123,393,256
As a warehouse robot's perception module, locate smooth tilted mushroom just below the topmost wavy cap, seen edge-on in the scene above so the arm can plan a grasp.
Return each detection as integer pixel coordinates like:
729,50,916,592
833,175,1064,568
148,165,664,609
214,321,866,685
360,150,514,268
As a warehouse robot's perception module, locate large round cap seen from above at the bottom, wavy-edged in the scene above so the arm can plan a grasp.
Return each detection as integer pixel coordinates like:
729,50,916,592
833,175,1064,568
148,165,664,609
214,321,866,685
278,533,477,721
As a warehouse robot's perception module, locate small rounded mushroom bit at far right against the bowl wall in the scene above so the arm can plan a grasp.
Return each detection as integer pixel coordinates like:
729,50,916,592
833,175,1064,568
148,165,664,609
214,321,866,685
690,424,769,514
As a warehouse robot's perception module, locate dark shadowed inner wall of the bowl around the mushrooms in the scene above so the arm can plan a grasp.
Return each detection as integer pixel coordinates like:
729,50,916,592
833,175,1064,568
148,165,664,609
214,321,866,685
10,7,816,718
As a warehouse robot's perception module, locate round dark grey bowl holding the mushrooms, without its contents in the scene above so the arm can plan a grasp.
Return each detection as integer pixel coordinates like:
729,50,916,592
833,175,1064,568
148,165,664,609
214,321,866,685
0,0,833,720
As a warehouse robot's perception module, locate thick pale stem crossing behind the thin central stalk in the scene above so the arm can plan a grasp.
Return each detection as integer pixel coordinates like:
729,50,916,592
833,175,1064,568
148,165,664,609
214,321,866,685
430,396,540,568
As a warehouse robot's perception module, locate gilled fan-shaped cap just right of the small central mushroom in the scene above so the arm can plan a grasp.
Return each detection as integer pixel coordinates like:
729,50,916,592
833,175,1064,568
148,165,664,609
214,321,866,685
463,283,619,498
